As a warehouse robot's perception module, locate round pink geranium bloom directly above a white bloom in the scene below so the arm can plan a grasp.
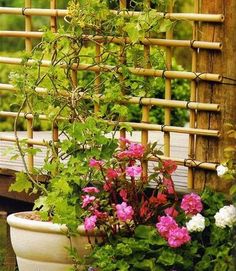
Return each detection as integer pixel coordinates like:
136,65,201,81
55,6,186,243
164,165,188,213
180,193,203,215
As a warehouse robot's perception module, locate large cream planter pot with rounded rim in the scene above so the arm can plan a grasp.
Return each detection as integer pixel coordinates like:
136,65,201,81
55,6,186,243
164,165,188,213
7,212,99,271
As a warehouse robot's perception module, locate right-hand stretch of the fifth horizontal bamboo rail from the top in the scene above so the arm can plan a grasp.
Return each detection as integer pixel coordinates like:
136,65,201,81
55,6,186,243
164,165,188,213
109,121,220,137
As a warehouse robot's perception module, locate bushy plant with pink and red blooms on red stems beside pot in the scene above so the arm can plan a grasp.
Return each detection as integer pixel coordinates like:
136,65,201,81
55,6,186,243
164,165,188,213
81,138,178,233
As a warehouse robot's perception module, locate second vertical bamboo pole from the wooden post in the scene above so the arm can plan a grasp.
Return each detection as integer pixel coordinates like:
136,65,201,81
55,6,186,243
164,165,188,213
164,0,173,156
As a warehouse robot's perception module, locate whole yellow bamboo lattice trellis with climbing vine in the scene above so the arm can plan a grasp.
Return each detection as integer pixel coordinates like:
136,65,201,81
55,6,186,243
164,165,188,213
0,0,225,189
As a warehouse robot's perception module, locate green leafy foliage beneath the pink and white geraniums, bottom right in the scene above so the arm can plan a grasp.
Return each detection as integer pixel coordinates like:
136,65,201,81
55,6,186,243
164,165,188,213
89,189,235,271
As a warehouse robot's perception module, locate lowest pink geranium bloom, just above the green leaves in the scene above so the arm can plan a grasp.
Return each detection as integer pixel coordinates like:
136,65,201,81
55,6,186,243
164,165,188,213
167,227,191,248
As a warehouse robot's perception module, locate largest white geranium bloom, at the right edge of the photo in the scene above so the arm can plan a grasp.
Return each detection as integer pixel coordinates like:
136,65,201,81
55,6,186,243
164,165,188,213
214,204,236,229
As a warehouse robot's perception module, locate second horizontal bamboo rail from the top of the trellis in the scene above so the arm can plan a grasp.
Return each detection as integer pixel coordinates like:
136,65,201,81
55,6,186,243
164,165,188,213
0,31,223,50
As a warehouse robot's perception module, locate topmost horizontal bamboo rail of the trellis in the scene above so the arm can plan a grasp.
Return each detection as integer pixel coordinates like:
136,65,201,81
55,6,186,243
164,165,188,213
0,7,224,23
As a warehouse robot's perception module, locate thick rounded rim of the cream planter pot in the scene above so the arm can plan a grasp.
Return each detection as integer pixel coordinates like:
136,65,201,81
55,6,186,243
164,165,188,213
7,211,98,236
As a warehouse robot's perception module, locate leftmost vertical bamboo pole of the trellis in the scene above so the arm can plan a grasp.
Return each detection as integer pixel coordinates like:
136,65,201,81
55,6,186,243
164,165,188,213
25,0,34,172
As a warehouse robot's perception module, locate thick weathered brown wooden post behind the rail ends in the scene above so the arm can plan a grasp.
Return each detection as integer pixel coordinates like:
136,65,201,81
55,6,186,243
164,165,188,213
194,0,236,192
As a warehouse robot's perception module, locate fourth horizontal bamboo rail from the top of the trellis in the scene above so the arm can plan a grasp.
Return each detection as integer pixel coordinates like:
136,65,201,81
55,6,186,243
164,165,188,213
0,84,220,111
